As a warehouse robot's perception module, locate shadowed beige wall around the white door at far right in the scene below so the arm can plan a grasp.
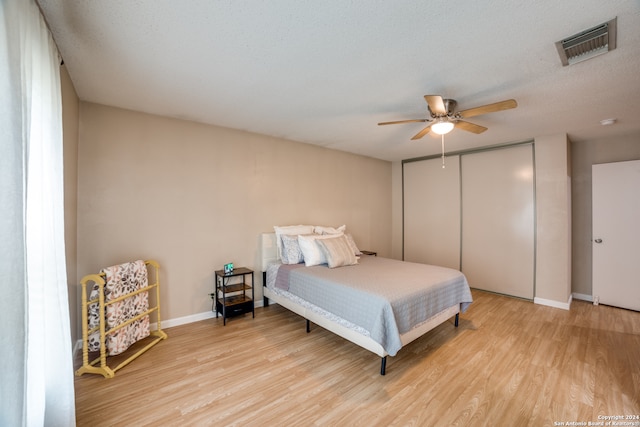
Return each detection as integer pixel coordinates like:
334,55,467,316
571,135,640,299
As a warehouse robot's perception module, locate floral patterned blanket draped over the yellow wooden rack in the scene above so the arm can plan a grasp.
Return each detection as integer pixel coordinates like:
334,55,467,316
89,260,149,356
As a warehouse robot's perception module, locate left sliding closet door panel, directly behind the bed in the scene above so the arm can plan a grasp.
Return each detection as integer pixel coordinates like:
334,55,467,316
403,156,460,269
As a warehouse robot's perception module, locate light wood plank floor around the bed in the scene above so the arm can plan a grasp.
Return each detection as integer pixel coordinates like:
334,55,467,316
75,290,640,426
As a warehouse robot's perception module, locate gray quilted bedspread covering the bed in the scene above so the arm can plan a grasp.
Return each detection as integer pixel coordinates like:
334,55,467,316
276,256,473,356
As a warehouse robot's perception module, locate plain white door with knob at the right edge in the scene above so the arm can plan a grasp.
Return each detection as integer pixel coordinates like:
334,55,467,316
591,160,640,311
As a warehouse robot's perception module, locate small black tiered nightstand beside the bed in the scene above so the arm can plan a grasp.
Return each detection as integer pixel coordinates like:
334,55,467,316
211,267,256,326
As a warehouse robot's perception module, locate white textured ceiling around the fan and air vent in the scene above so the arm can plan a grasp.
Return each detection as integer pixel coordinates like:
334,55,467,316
38,0,640,160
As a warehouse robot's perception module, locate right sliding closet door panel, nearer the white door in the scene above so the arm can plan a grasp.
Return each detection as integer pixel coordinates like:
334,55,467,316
461,144,535,299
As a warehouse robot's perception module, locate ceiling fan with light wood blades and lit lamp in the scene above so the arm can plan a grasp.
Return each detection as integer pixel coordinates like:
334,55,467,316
378,95,518,140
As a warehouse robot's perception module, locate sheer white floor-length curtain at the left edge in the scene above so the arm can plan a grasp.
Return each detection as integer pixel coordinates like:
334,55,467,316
0,0,75,427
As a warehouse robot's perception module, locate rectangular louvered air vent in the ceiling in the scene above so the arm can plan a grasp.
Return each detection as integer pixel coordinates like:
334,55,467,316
556,18,618,66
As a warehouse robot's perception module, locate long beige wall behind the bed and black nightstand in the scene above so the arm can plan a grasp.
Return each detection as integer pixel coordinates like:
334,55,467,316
77,102,392,326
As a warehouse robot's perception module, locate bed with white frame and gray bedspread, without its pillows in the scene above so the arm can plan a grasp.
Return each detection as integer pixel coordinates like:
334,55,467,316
260,233,472,375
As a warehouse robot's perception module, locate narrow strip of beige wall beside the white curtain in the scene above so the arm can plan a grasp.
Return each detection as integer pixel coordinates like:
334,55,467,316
60,66,82,342
